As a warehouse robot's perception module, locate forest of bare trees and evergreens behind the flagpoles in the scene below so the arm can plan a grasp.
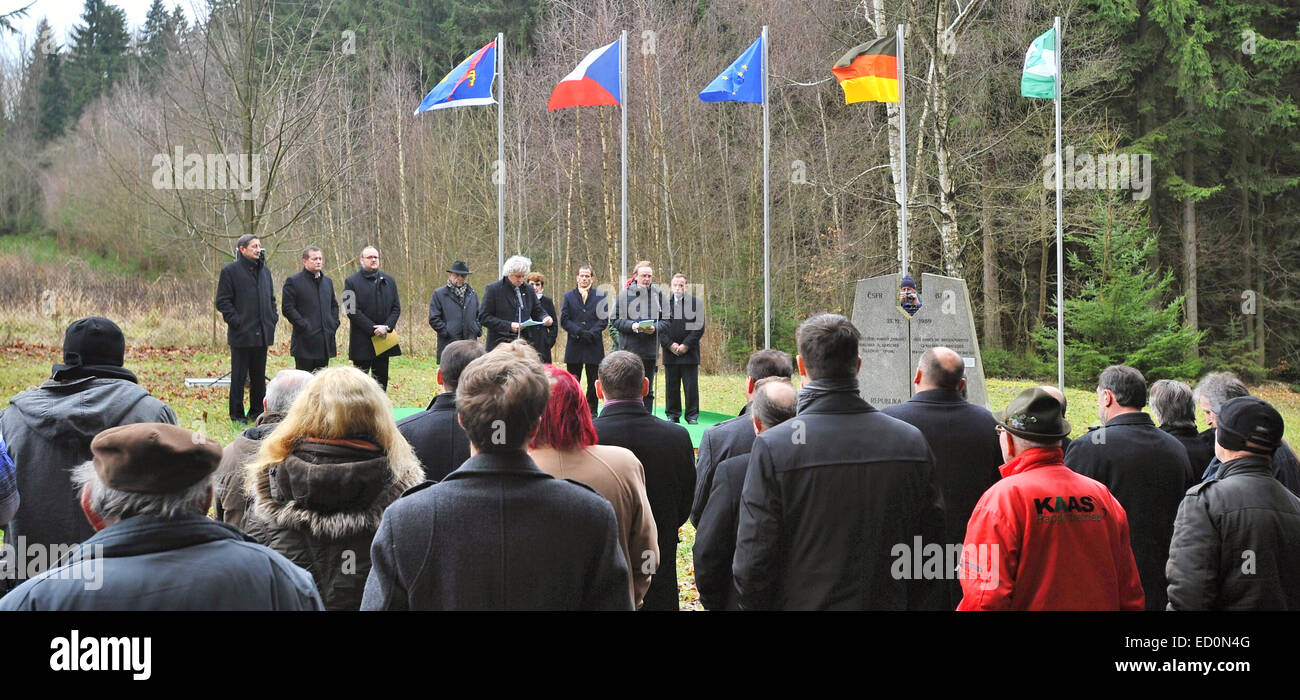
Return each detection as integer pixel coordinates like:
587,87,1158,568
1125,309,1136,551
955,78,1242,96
0,0,1300,385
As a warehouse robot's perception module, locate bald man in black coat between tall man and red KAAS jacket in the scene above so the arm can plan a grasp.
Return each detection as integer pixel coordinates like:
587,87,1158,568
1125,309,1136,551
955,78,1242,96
881,346,1002,608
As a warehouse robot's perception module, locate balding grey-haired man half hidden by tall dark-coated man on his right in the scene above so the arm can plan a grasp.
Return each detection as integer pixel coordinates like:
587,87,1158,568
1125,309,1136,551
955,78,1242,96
692,377,797,610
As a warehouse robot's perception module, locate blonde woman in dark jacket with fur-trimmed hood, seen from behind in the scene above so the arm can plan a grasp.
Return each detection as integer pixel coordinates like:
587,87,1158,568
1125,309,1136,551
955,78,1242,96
244,367,424,610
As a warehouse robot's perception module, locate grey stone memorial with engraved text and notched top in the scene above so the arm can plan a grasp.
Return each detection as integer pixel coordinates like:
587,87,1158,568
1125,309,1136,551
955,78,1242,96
853,273,988,409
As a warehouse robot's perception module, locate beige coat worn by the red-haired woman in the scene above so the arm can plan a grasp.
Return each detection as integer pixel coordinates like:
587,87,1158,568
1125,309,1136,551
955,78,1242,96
528,445,655,608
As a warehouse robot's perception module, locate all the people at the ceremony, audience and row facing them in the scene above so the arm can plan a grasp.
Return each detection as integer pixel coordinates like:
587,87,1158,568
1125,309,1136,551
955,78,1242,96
0,238,1300,610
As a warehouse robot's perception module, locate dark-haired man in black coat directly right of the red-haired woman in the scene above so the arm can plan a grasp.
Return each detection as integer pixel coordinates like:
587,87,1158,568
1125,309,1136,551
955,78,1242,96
594,350,696,610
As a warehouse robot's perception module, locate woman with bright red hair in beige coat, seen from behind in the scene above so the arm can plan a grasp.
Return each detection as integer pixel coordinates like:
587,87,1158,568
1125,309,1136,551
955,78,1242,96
528,364,660,608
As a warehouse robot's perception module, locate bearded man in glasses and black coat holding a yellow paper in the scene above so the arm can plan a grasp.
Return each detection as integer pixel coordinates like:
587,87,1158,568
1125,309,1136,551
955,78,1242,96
343,246,402,392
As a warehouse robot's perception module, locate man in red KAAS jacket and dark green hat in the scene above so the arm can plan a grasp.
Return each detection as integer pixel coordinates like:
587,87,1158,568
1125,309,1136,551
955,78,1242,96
957,388,1144,610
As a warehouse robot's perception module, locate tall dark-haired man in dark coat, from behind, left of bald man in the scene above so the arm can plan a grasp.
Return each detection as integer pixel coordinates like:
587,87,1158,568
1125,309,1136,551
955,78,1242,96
732,314,948,610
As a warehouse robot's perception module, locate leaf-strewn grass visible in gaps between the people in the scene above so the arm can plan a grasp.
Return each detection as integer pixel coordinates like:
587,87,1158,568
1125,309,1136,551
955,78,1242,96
0,343,1300,609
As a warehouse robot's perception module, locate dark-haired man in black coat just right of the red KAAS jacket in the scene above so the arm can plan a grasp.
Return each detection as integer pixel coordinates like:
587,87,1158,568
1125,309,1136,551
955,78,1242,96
1065,364,1197,610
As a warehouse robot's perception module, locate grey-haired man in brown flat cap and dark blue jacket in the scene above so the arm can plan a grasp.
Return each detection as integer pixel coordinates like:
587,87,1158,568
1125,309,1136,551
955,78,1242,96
0,423,322,610
